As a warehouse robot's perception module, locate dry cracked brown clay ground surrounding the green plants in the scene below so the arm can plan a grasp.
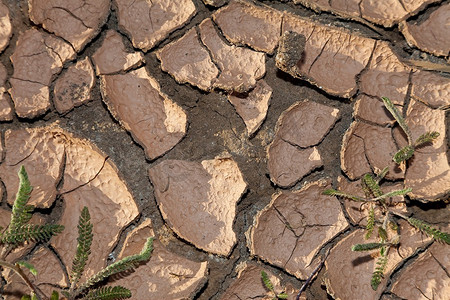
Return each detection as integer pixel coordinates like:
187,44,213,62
0,0,450,300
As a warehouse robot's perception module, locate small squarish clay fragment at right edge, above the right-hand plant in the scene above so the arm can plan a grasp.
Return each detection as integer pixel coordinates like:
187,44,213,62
411,71,450,109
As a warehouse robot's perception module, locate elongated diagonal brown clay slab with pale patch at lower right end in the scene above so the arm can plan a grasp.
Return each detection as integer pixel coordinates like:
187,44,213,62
101,67,187,159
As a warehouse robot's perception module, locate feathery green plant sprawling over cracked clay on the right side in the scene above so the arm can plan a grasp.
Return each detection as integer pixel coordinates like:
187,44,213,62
323,97,450,290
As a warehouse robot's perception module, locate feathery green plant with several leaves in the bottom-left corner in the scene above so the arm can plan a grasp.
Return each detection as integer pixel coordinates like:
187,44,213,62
0,166,153,300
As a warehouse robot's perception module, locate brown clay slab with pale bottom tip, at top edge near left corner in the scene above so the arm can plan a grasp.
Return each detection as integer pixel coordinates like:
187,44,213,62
28,0,111,52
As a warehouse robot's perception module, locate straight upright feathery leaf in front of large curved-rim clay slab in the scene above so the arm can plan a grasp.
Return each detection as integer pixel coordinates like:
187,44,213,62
70,206,94,289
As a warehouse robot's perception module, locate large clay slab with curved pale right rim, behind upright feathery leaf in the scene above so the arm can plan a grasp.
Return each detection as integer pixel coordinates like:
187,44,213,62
51,133,139,282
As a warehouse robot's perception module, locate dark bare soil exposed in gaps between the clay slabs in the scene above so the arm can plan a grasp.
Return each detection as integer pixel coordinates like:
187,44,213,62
0,0,450,300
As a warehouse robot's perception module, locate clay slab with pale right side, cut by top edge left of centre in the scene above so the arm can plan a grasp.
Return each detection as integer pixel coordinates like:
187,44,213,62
116,0,197,52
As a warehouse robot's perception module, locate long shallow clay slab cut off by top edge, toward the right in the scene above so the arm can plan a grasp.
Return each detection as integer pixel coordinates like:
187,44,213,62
294,0,439,27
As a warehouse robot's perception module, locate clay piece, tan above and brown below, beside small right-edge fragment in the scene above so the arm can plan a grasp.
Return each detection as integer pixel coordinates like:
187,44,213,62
360,41,411,105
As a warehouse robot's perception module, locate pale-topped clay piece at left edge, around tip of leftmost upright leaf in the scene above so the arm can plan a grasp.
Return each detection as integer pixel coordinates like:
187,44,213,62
0,127,65,208
